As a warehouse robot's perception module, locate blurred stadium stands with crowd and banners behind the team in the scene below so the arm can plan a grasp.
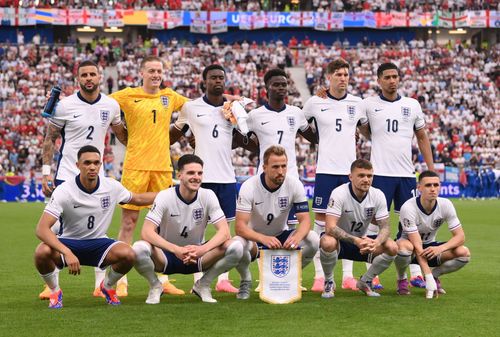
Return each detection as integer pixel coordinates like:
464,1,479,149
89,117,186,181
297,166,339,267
0,0,500,201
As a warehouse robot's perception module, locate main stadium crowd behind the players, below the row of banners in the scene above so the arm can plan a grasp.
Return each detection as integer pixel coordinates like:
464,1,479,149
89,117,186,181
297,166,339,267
0,34,500,194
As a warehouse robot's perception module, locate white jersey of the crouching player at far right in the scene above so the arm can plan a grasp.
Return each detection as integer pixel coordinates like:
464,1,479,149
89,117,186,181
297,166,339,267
399,197,461,243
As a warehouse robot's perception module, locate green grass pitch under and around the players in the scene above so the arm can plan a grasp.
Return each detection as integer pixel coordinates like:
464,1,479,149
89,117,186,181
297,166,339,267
0,200,500,337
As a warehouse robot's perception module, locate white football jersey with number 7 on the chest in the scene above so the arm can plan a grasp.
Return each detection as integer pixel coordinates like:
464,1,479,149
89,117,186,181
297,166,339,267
247,104,309,177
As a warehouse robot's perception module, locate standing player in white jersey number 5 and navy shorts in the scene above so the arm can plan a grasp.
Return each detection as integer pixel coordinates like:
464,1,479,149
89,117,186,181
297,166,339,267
302,59,372,292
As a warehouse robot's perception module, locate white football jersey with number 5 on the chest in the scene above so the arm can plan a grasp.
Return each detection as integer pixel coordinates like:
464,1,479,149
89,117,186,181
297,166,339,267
302,94,361,175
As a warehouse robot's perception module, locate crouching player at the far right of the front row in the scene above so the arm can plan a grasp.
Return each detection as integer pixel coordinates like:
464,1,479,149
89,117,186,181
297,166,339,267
394,171,470,298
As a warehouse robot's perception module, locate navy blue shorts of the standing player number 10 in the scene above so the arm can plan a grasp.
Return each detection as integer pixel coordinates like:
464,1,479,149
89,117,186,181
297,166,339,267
372,175,417,212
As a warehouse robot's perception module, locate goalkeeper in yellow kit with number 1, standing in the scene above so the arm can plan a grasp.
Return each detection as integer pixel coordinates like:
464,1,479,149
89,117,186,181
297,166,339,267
111,56,188,296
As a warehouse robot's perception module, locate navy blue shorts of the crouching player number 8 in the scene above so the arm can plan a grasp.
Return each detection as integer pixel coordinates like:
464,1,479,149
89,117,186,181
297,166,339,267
59,238,119,268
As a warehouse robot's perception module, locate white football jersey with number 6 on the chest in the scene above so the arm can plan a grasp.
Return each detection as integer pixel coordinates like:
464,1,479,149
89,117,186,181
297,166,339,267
176,96,236,184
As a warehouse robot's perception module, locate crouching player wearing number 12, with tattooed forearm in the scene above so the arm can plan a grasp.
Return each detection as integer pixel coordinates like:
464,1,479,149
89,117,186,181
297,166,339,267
320,159,398,298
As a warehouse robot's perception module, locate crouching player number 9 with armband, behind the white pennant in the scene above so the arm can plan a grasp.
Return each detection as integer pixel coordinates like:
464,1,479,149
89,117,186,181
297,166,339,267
235,145,319,300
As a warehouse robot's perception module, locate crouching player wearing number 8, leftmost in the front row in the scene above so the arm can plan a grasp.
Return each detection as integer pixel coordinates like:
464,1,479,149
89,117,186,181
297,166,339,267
35,145,156,309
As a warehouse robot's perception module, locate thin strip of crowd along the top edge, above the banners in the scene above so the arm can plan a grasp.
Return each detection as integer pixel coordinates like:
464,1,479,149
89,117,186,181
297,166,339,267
0,0,498,12
